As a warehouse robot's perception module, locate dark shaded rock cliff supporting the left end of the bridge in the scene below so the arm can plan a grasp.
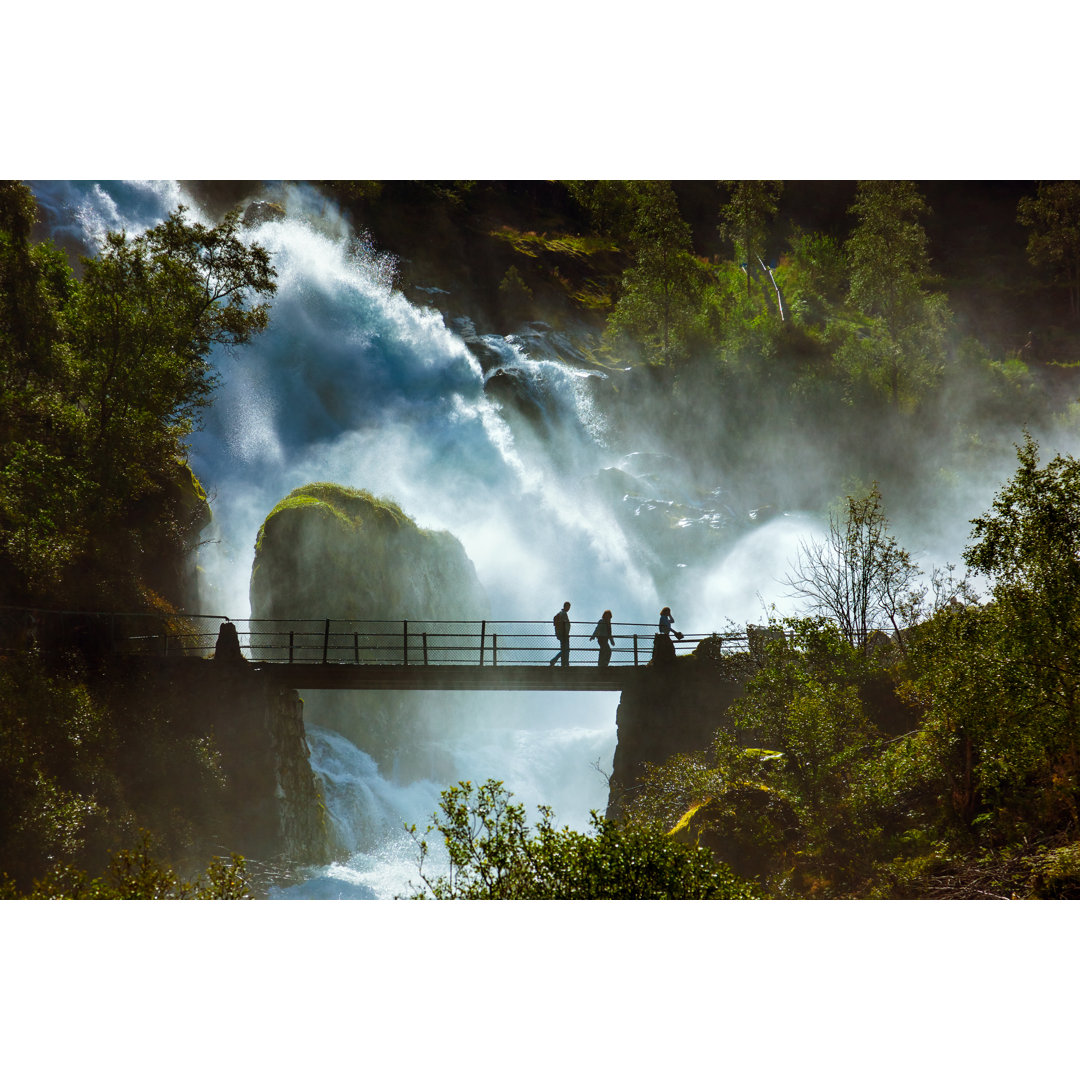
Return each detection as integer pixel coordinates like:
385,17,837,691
109,656,334,889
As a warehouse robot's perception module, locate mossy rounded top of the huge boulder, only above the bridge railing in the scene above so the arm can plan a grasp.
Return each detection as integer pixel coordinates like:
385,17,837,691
251,484,489,620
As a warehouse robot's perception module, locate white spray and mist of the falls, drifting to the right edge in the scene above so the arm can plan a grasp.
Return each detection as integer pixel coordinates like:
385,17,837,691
32,181,1078,895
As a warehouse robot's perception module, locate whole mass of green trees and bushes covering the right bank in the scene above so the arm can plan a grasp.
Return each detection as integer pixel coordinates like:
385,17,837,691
631,437,1080,896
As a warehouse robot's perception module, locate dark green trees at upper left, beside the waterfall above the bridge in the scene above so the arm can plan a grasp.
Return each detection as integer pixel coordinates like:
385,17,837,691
0,183,275,607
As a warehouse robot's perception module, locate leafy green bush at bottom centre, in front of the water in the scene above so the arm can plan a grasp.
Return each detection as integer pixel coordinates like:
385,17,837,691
410,780,755,900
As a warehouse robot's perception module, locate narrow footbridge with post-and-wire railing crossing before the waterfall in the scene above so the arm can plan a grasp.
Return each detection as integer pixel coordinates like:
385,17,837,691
6,608,748,691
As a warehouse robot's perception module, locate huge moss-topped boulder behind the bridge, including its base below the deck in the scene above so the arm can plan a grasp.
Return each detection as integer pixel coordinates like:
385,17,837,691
251,484,490,781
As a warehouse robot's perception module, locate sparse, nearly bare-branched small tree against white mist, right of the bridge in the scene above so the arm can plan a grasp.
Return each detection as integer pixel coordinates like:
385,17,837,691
785,483,921,650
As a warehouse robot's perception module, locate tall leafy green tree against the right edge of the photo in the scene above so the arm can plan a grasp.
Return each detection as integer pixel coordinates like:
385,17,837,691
914,435,1080,821
